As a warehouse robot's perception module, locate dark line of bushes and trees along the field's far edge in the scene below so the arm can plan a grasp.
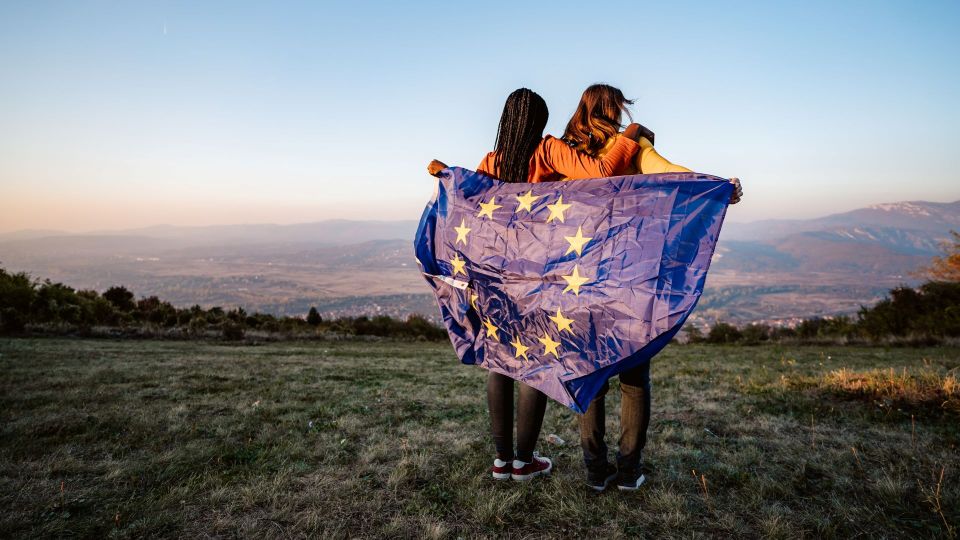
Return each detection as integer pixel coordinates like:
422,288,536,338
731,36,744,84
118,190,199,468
0,232,960,345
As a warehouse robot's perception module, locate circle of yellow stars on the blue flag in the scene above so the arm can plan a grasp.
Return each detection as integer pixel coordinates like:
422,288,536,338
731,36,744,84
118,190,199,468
449,190,593,360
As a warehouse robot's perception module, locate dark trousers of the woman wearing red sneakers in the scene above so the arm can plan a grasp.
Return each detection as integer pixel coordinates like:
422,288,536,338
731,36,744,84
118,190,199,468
487,371,547,463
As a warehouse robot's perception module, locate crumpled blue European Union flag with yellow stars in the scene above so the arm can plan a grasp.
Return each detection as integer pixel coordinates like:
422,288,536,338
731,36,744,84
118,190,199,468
414,168,734,413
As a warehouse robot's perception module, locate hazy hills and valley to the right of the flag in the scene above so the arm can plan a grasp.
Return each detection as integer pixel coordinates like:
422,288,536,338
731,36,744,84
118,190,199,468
694,201,960,324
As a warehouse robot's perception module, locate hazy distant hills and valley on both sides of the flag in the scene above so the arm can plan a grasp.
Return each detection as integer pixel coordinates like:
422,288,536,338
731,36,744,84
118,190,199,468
0,201,960,324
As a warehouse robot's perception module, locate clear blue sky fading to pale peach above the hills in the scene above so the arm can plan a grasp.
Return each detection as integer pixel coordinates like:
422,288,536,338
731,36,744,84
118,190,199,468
0,1,960,231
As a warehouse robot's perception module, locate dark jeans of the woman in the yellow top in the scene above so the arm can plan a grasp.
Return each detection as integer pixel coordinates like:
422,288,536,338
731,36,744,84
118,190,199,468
580,362,650,468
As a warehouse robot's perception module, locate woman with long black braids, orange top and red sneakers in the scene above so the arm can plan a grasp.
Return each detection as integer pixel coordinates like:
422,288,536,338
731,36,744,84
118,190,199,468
427,88,640,480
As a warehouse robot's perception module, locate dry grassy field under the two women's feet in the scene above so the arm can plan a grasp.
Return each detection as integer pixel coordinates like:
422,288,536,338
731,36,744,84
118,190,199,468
0,339,960,538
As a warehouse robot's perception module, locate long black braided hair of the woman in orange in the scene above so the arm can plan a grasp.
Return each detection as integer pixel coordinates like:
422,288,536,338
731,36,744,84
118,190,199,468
493,88,549,182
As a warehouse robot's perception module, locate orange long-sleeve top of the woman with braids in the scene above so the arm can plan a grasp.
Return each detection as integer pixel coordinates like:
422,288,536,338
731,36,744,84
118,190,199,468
477,135,640,183
